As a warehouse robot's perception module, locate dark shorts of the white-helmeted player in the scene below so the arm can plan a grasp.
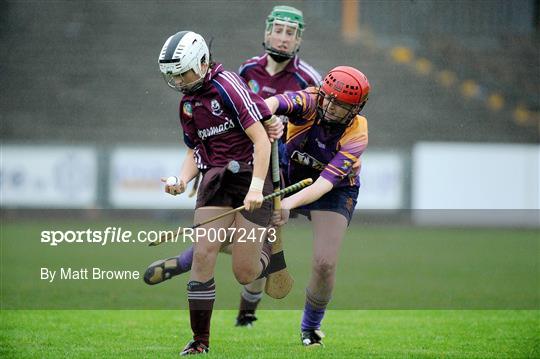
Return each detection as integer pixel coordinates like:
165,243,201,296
195,161,273,227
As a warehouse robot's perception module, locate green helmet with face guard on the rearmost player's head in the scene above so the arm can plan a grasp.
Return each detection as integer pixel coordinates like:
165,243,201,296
263,6,304,62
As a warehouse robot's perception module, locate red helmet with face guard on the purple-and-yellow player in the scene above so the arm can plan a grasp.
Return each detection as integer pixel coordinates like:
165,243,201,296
317,66,371,125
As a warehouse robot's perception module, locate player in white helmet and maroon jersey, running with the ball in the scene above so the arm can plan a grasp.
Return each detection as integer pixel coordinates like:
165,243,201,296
155,31,272,355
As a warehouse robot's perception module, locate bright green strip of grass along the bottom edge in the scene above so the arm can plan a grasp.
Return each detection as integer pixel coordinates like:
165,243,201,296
0,310,540,358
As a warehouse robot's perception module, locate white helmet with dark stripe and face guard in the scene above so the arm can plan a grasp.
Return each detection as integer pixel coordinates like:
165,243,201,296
159,31,210,93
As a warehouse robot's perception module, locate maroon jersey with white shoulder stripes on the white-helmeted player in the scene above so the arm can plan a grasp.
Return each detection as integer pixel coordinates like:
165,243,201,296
180,64,272,170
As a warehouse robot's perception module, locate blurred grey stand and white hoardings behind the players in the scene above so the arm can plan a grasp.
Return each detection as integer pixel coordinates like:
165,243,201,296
0,0,540,225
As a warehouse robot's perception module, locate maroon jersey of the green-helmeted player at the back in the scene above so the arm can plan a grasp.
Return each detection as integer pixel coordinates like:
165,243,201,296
238,54,321,98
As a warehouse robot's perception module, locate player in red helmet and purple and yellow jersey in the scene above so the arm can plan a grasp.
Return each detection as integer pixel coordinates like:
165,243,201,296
265,66,370,346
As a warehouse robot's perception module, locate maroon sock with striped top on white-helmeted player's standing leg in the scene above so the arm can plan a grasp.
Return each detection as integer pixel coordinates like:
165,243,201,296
187,278,216,347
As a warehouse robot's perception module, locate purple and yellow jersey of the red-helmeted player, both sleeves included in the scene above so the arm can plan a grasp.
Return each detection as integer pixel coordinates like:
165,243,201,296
276,88,368,187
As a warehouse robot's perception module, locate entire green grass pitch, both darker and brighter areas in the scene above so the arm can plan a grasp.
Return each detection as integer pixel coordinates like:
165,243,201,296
0,218,540,358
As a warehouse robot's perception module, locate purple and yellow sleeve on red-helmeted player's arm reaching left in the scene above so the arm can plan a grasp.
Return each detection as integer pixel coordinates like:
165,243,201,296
275,91,317,124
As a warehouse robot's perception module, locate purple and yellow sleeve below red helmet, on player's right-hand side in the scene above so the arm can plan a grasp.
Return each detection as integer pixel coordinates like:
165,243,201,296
321,117,368,186
